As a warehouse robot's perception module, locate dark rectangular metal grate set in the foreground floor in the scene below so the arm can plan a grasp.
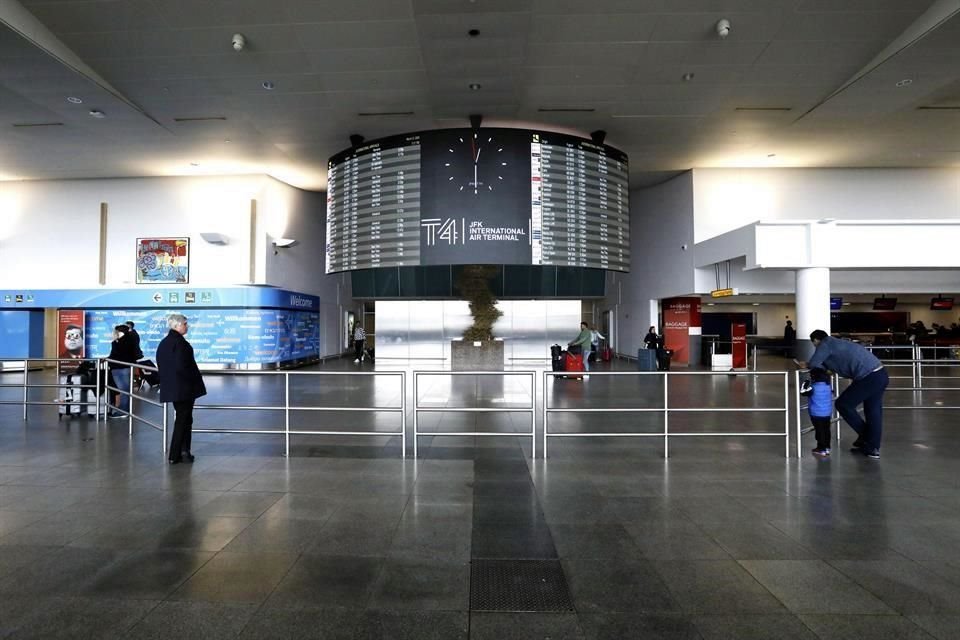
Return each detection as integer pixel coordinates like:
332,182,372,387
470,559,573,611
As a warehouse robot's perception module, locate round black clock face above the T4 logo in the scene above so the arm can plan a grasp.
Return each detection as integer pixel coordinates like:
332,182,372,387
444,132,507,196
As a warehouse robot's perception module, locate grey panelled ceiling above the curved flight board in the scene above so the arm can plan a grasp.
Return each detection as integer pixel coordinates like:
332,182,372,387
0,0,960,188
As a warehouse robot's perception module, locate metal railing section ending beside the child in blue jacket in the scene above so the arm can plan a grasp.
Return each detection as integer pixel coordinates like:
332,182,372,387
542,371,790,458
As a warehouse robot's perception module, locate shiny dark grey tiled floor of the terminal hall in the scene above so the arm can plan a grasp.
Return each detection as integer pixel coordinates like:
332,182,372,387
0,361,960,640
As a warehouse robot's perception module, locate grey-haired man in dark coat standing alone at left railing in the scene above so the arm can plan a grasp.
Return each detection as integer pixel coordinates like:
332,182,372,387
157,313,207,464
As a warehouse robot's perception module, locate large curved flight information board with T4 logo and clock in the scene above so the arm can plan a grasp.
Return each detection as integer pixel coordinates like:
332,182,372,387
326,128,630,273
